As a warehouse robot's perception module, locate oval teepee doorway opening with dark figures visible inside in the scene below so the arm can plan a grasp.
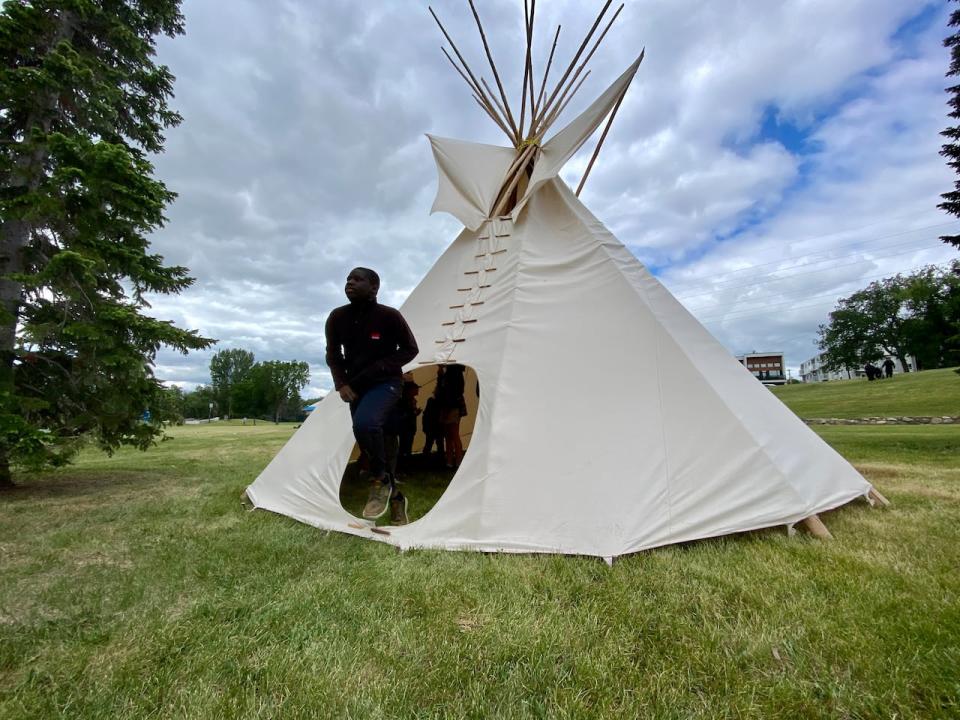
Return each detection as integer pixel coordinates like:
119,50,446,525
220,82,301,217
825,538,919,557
340,363,480,524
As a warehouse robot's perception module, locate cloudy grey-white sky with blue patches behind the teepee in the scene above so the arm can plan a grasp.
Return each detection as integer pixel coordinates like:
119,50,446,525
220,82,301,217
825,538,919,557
146,0,960,396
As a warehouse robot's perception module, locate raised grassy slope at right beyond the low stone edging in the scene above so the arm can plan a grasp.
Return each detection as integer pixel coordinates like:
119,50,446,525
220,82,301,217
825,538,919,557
773,368,960,418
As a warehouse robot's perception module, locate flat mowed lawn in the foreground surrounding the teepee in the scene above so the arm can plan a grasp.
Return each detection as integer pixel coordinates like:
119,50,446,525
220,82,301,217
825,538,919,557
0,373,960,718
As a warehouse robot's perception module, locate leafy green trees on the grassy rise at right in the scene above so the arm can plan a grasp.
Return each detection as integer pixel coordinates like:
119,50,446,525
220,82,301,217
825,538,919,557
819,260,960,371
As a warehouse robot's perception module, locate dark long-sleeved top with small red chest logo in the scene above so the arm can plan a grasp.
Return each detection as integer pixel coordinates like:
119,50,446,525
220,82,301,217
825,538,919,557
325,299,418,395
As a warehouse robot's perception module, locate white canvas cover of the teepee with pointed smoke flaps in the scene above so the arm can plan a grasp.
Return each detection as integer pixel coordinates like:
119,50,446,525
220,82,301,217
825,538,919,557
247,2,872,558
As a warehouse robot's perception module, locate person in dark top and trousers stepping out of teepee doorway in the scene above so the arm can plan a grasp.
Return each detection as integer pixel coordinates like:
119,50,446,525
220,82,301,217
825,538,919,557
325,267,418,525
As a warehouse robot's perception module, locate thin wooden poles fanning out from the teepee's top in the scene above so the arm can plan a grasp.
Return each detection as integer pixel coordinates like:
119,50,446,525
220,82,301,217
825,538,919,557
428,0,636,216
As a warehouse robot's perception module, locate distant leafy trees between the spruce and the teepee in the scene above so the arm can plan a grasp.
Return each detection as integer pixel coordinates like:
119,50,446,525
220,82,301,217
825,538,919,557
164,348,310,422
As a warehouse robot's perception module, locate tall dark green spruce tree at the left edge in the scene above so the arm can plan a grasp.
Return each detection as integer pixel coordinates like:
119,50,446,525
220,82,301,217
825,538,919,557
0,0,212,485
